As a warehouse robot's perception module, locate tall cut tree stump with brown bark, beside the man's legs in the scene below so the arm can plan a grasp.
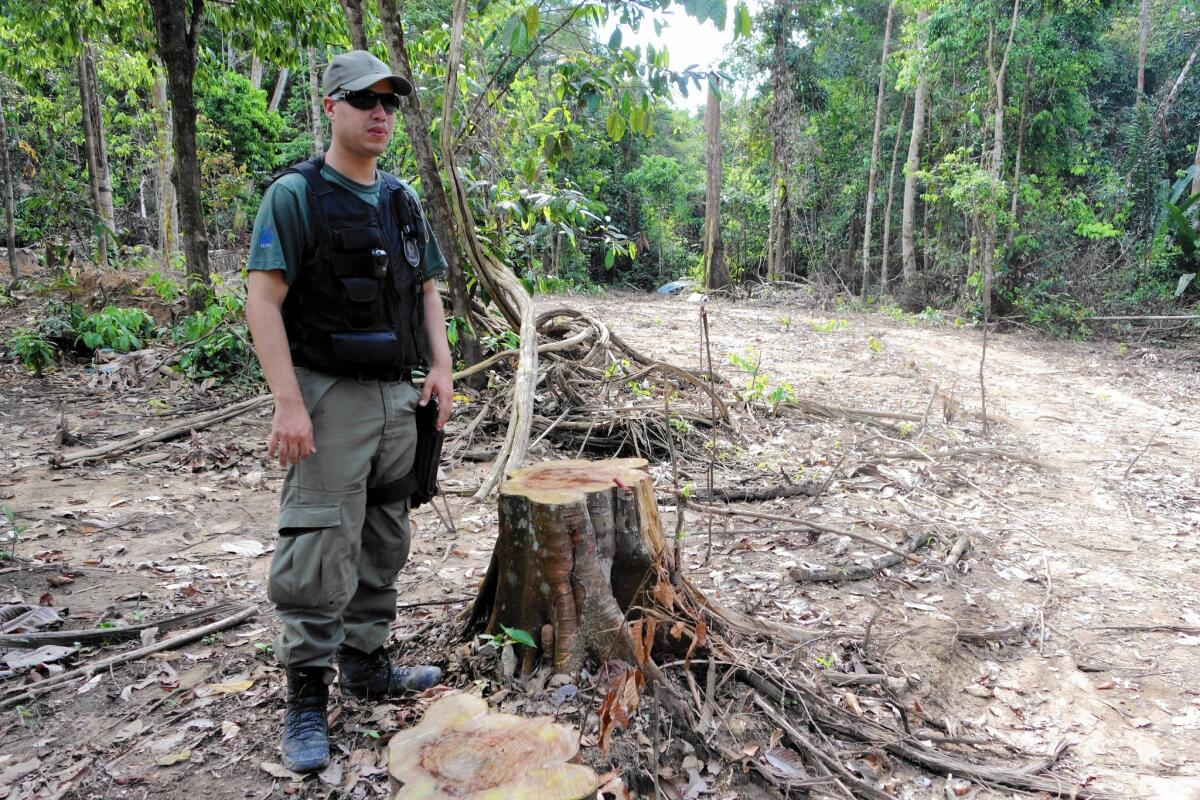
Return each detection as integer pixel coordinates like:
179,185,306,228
467,458,681,673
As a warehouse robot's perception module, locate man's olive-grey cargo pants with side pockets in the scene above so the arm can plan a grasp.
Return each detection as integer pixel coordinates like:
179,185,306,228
268,367,420,680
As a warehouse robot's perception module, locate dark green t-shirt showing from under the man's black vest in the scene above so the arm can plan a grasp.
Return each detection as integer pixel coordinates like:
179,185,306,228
247,164,446,285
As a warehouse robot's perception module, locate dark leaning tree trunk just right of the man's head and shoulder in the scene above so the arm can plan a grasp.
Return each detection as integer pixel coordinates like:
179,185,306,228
376,0,487,387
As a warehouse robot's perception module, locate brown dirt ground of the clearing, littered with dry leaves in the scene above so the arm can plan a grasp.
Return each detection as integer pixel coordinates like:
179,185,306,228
0,294,1200,800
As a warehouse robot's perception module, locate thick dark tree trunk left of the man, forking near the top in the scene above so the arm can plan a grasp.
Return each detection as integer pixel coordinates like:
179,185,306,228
150,0,209,311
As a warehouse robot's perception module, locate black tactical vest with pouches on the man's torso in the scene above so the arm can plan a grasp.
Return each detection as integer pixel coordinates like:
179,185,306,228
283,156,428,380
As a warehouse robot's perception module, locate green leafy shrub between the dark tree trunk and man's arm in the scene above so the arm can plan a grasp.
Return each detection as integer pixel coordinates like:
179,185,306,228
172,294,258,380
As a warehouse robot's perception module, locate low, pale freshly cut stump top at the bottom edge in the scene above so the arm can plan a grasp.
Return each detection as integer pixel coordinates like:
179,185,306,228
388,693,596,800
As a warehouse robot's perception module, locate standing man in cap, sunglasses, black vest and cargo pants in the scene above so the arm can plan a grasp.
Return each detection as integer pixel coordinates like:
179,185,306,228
246,50,452,772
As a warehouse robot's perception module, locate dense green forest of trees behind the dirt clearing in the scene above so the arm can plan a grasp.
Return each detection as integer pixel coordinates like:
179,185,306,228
0,0,1200,345
